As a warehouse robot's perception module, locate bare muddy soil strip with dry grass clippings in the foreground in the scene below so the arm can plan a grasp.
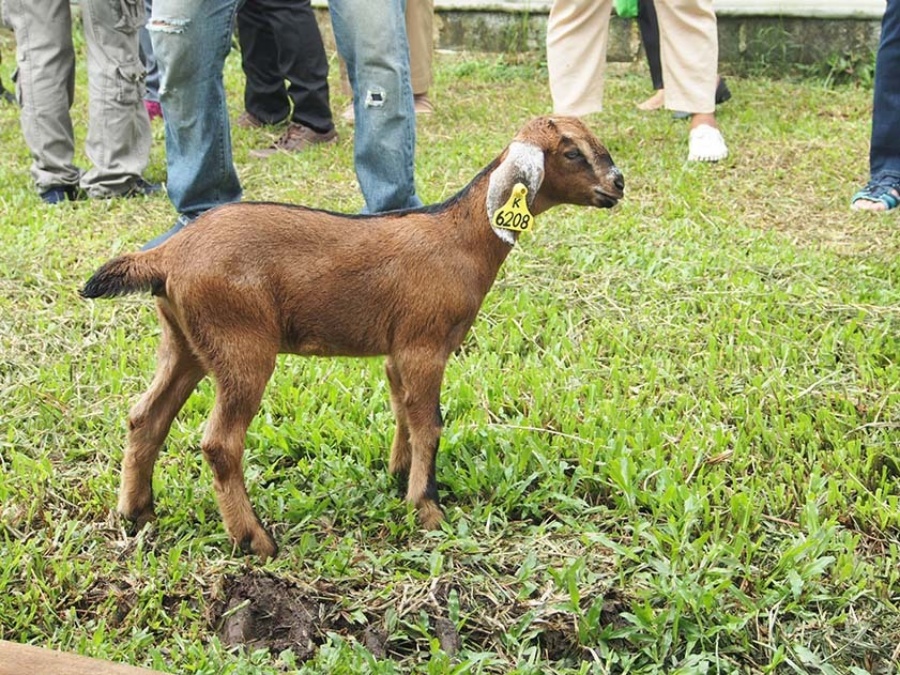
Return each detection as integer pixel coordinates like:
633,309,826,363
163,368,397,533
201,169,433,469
209,573,625,662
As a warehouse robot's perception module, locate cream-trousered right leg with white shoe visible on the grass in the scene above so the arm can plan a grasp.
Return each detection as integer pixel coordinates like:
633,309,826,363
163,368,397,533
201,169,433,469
656,0,728,162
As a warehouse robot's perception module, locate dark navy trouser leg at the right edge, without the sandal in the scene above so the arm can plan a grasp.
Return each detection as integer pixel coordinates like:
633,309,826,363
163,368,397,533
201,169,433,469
869,0,900,180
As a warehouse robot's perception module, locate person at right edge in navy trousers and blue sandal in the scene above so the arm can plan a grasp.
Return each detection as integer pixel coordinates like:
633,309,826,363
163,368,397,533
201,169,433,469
850,0,900,211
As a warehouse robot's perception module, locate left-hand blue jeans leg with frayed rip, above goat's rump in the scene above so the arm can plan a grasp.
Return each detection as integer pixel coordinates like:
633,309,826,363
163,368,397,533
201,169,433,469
147,0,241,218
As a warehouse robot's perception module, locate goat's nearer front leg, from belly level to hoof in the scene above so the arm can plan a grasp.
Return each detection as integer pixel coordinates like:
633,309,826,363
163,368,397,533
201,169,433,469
392,353,447,530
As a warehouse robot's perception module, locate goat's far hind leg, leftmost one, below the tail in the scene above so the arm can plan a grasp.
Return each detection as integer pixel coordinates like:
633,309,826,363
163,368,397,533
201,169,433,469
117,307,206,529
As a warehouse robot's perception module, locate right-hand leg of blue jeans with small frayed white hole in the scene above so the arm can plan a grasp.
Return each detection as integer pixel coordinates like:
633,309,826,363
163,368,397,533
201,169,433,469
329,0,422,213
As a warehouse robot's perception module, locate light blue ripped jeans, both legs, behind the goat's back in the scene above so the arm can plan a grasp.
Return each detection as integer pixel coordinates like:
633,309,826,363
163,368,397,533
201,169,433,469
147,0,421,219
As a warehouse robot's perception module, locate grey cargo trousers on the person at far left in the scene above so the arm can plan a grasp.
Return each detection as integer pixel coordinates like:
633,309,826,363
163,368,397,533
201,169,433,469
4,0,151,197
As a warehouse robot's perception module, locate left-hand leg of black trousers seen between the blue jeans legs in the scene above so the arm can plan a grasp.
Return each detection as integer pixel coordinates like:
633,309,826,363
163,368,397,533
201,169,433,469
237,0,288,124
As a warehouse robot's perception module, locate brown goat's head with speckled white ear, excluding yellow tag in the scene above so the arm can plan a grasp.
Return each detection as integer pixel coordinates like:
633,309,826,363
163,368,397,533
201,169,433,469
487,117,625,243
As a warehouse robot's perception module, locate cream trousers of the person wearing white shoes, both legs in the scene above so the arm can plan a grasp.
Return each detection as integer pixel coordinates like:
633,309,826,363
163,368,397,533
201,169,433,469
547,0,719,115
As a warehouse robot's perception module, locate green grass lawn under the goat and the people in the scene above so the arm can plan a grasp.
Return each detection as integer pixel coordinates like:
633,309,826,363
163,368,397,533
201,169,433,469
0,25,900,673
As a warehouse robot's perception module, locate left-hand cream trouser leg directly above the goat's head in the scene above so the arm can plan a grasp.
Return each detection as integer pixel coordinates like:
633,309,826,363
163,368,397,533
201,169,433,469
547,0,612,115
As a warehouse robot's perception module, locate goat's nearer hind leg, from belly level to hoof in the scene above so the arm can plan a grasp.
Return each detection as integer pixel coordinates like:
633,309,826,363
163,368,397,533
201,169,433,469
201,355,278,561
